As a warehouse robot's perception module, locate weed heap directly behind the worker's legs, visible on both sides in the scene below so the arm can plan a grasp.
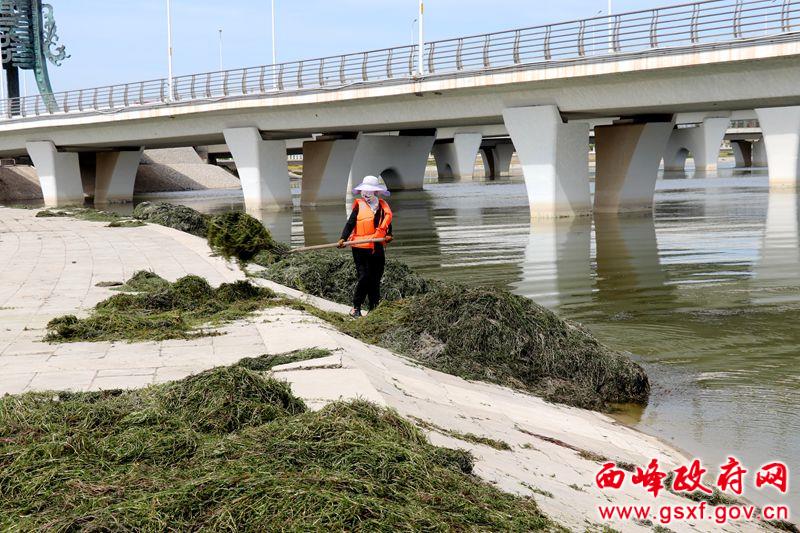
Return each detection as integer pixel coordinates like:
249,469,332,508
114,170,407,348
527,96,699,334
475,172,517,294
257,250,437,305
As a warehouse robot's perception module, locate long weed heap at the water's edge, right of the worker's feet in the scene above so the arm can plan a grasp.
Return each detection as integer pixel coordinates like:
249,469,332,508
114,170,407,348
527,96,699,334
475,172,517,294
326,284,650,410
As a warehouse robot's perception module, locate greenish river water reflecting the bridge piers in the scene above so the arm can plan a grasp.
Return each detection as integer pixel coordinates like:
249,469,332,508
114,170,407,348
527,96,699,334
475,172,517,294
133,165,800,510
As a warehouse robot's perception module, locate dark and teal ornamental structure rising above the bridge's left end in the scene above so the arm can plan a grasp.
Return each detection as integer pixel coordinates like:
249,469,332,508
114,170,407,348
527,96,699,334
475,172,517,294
0,0,69,114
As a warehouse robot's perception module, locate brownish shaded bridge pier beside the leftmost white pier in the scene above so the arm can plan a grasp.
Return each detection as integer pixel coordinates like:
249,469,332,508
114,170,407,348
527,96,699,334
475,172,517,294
94,148,144,204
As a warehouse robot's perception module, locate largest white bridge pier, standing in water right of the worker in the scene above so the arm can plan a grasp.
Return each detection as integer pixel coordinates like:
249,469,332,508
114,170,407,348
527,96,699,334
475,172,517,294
503,106,591,218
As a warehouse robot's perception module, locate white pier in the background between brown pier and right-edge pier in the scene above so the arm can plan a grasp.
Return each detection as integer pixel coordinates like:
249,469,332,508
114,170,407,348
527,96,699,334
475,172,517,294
664,117,731,172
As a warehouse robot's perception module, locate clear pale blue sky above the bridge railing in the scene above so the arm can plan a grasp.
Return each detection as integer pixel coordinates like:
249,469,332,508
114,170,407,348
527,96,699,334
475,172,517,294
31,0,668,94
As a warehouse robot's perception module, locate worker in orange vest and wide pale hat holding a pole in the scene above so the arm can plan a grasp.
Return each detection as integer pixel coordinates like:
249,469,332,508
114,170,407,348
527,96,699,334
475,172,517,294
339,176,392,318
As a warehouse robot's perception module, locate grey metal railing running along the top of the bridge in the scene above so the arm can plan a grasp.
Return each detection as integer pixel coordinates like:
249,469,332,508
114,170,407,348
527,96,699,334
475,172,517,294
0,0,800,122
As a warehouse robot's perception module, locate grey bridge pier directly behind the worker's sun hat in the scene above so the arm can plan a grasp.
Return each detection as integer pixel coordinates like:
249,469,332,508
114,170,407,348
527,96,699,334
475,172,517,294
350,133,436,191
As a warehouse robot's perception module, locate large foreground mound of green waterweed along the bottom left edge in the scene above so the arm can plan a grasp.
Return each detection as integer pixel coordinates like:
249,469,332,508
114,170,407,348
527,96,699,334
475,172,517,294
0,365,561,531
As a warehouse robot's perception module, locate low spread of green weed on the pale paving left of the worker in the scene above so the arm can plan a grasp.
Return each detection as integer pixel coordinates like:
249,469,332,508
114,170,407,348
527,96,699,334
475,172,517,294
45,272,275,342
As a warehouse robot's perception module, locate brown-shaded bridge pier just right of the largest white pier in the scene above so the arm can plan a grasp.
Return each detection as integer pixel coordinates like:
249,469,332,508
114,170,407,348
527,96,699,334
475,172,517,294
594,122,673,213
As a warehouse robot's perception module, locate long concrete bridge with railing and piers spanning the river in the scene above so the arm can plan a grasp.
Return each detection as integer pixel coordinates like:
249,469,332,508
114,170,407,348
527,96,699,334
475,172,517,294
0,0,800,217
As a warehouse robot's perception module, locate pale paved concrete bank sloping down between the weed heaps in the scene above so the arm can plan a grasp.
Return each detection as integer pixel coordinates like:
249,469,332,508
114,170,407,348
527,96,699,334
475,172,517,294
0,208,772,531
